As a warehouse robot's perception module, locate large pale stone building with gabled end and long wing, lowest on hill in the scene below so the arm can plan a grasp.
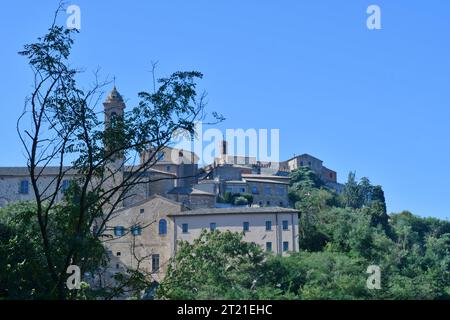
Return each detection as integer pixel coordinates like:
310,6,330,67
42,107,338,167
104,195,299,282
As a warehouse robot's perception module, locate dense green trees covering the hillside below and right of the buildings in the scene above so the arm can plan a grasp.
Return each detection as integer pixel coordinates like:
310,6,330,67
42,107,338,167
158,168,450,300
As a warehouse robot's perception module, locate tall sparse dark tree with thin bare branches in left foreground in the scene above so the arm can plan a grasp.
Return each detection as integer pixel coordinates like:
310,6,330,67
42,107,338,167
17,8,222,299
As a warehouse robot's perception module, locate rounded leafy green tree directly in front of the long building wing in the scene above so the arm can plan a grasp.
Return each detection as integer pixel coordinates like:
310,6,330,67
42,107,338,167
157,230,265,299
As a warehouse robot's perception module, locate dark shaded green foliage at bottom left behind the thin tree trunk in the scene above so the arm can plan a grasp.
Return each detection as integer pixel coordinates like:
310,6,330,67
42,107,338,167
0,202,106,299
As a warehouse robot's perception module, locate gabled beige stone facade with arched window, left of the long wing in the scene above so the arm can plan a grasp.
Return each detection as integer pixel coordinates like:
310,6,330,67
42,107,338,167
104,195,187,282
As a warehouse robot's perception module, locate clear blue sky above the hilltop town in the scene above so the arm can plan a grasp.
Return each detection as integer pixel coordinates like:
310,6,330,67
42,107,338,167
0,0,450,218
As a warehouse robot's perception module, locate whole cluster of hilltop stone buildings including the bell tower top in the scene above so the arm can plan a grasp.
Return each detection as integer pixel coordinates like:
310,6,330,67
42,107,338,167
0,88,340,288
